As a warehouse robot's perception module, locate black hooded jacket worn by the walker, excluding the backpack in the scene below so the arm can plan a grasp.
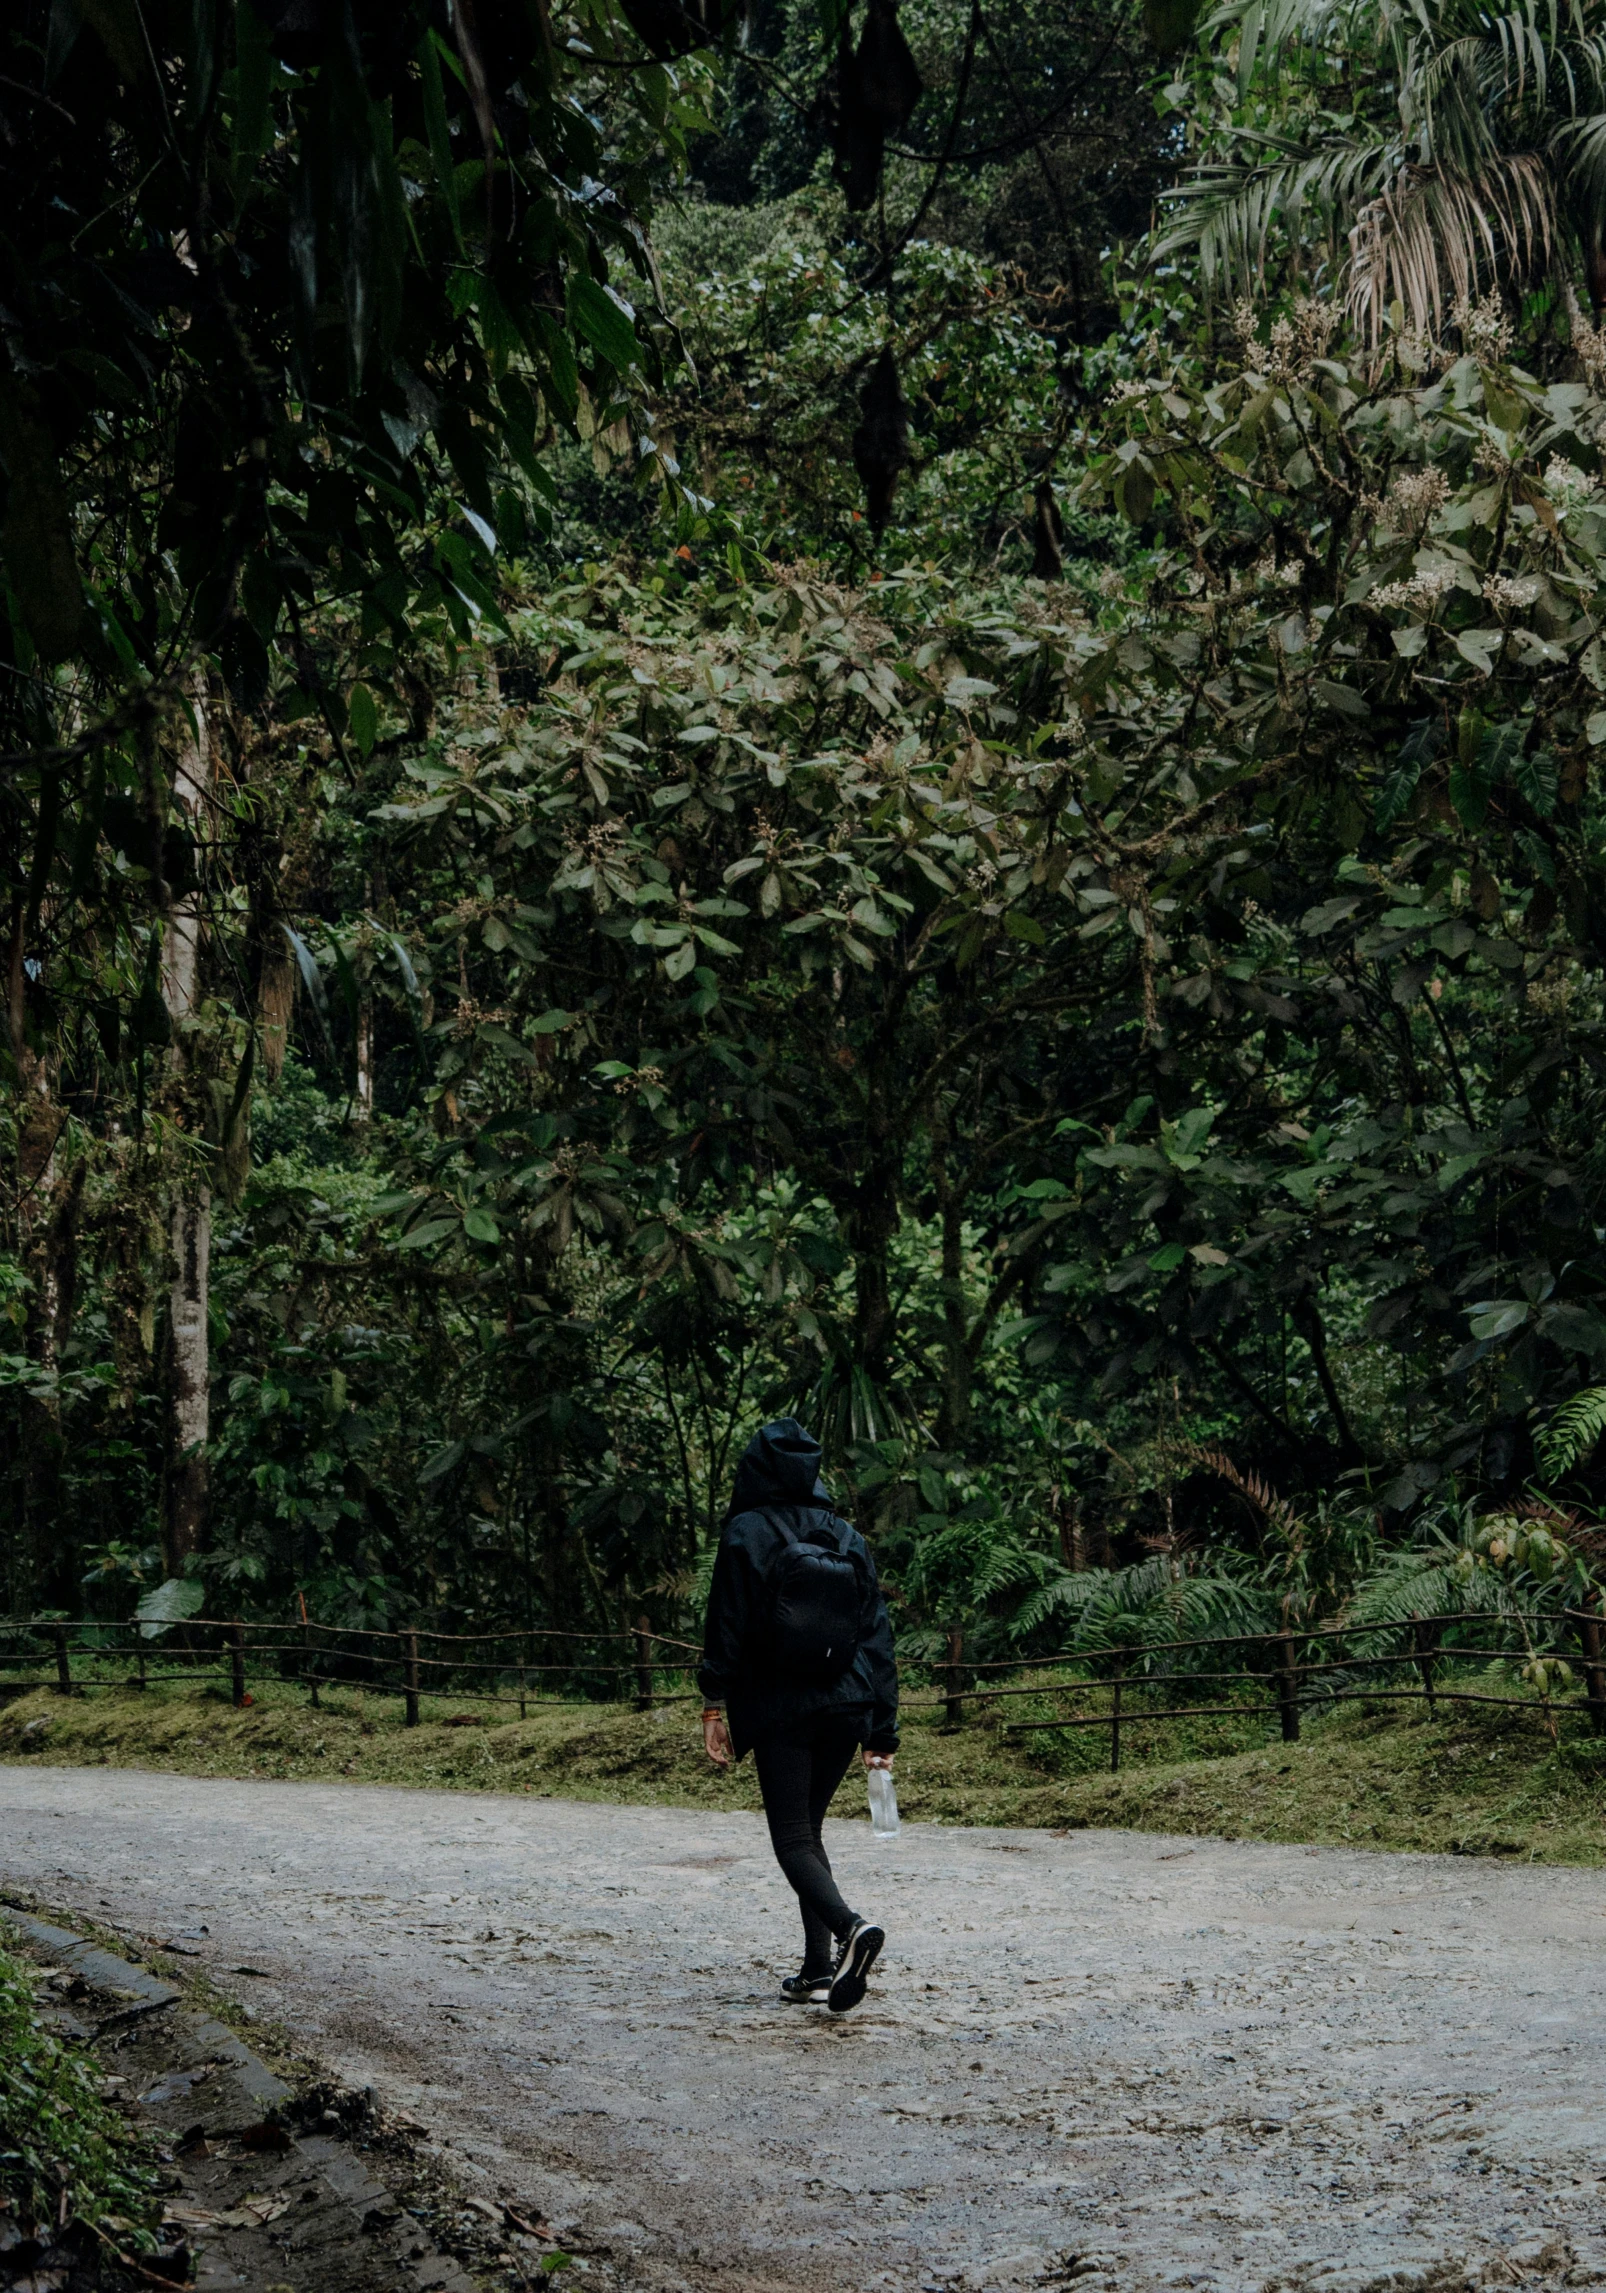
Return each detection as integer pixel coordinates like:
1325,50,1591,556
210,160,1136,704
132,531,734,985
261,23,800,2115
697,1417,897,1759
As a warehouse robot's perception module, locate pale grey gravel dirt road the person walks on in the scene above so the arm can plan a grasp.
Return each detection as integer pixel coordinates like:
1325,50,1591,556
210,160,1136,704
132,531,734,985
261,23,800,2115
0,1766,1606,2293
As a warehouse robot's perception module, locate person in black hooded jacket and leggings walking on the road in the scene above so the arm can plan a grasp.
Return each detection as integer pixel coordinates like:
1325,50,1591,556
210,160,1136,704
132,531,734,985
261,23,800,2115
697,1417,897,2013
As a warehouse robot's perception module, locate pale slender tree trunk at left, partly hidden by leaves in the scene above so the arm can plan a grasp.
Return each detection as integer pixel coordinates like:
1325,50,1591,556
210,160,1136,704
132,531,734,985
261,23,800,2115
163,674,211,1575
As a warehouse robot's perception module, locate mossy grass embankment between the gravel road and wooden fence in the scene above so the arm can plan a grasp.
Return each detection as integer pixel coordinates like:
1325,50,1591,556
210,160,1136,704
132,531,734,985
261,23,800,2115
0,1678,1606,1864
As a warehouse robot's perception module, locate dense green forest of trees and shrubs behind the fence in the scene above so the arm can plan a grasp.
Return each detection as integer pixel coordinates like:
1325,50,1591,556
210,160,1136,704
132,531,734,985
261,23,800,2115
0,0,1606,1662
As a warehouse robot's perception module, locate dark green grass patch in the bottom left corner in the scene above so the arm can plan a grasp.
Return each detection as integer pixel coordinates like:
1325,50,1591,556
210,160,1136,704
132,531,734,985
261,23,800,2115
0,1926,161,2256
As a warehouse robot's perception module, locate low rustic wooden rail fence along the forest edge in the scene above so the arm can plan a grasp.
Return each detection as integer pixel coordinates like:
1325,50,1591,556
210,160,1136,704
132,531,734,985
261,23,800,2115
0,1607,1606,1768
